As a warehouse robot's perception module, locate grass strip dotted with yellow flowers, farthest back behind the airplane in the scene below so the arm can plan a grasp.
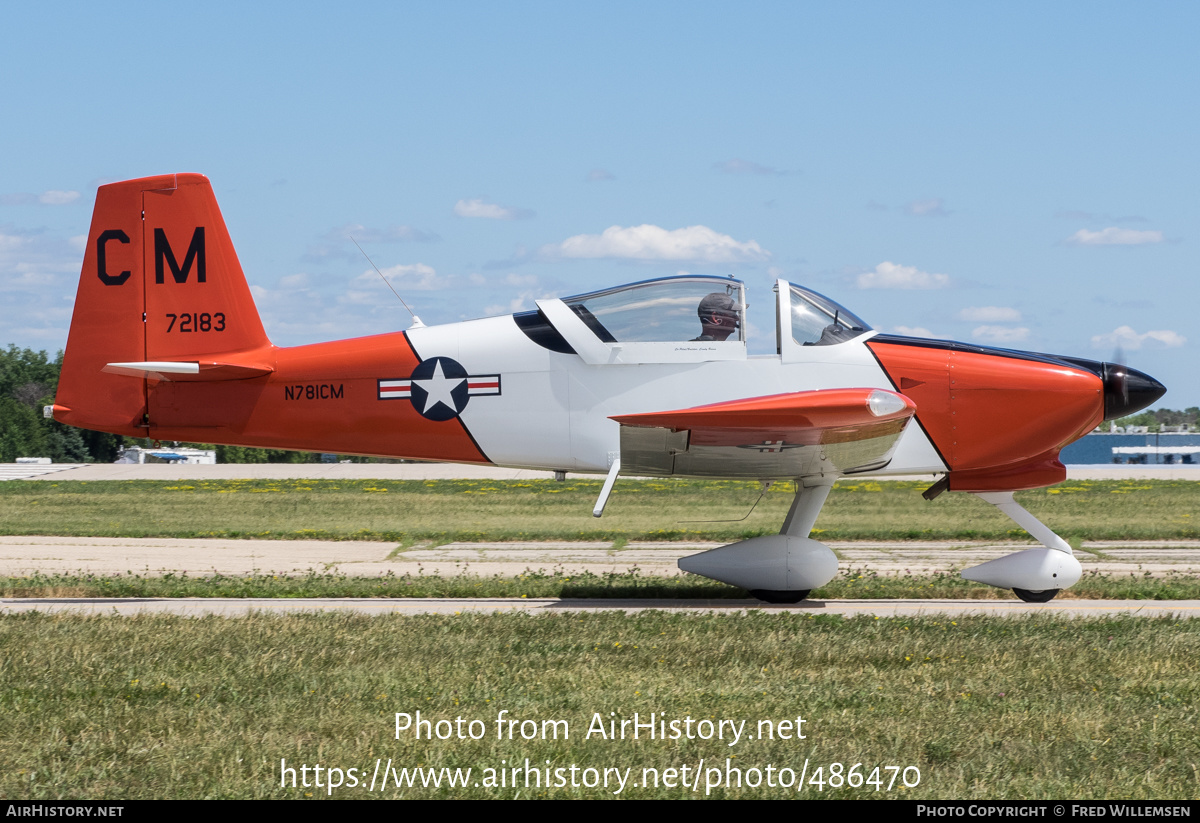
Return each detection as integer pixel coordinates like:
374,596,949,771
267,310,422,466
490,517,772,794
0,479,1200,545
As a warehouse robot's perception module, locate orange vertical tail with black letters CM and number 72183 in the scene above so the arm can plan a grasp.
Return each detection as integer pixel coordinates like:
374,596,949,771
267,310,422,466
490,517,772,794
54,174,274,437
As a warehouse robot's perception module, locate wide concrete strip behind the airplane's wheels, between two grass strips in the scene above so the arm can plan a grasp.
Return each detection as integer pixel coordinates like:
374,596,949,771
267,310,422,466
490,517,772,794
0,536,1200,577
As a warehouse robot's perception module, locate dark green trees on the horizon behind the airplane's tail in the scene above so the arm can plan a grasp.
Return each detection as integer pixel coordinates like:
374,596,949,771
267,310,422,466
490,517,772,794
0,346,379,463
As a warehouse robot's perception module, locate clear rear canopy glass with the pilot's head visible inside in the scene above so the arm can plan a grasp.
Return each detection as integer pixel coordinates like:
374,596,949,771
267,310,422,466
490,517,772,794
563,275,745,343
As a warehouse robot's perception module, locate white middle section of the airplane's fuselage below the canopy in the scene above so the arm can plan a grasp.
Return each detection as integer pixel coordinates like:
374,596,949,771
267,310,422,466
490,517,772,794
407,316,947,474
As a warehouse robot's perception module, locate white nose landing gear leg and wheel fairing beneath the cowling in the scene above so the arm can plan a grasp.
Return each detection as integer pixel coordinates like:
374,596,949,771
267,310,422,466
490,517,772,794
962,492,1084,603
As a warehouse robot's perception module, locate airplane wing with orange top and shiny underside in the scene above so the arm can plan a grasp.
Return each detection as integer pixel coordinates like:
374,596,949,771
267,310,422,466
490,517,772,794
612,389,917,480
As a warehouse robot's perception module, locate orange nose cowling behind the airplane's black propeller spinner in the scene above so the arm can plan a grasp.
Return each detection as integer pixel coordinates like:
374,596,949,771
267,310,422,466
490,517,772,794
869,337,1104,491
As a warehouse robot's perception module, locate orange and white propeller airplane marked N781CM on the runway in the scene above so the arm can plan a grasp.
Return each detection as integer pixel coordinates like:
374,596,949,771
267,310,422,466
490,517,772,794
47,174,1165,602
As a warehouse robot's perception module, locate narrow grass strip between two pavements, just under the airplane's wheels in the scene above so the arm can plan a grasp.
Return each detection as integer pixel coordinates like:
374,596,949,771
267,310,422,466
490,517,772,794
0,569,1200,600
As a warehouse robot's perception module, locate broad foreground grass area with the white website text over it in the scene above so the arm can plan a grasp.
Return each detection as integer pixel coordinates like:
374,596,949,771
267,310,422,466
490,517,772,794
0,612,1200,800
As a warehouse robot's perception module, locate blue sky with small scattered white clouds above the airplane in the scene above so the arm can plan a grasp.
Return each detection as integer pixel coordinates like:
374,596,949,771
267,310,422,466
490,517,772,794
0,2,1200,408
